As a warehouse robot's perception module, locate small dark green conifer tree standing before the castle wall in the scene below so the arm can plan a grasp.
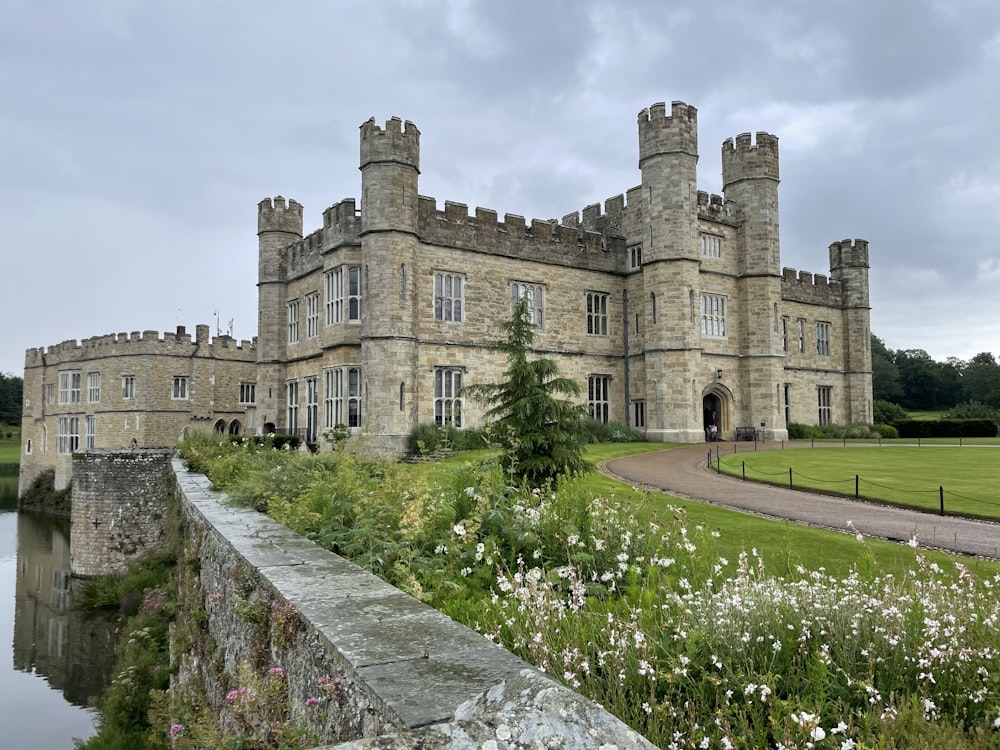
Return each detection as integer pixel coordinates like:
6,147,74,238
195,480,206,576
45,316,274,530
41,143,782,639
462,298,589,485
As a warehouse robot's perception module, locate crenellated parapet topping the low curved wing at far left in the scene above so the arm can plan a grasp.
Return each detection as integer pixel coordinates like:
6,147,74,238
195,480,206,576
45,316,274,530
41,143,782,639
24,325,257,369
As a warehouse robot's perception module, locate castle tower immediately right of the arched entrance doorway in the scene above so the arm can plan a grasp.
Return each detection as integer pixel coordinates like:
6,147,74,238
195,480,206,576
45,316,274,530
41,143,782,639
722,133,788,439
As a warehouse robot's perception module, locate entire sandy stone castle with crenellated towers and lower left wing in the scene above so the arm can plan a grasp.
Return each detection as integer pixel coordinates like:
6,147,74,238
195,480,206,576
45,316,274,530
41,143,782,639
22,102,872,476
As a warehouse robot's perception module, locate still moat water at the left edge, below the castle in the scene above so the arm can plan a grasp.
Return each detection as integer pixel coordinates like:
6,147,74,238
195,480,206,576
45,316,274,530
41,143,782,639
0,477,114,750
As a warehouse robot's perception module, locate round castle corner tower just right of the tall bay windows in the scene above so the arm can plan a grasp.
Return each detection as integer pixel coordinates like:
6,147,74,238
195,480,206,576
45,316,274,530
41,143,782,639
360,117,422,452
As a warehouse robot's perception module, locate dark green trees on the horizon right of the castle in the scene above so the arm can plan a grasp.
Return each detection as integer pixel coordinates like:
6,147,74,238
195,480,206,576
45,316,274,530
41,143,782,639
872,335,1000,411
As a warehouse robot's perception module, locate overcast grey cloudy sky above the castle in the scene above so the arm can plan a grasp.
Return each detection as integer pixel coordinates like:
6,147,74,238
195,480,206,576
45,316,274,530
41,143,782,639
0,0,1000,374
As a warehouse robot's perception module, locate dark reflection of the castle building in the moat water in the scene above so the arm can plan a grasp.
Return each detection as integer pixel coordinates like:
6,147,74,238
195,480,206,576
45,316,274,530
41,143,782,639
14,511,115,706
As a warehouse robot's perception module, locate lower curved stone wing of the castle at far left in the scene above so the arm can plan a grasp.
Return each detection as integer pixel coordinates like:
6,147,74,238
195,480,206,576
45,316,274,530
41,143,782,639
18,325,257,495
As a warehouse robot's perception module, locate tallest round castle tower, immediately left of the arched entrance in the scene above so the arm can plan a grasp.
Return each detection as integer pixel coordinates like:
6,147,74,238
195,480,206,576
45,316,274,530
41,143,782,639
638,102,704,441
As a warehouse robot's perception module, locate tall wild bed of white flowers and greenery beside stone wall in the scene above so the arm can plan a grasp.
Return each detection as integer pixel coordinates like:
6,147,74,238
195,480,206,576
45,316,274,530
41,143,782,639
182,444,1000,750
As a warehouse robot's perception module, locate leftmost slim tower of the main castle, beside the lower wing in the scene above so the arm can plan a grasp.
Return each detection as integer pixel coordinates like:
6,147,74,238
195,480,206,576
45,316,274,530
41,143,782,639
257,195,302,428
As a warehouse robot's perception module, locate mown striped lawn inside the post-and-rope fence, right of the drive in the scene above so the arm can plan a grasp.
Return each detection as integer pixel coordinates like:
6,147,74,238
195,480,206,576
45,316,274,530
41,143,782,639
721,439,1000,519
